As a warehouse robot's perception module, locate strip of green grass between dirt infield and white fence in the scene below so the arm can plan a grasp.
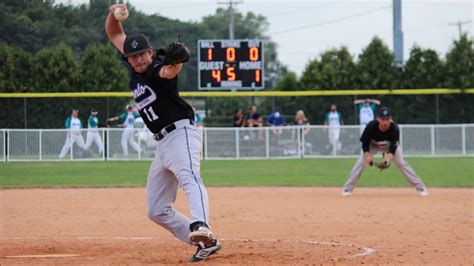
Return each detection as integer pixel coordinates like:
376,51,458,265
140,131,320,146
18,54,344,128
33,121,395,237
0,157,474,188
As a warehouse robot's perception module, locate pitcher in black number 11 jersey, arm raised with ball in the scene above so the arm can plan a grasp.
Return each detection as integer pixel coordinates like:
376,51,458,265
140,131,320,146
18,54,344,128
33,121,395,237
105,4,221,262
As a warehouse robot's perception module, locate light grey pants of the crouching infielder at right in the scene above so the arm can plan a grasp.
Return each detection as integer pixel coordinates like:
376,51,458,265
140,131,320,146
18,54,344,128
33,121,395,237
344,144,426,191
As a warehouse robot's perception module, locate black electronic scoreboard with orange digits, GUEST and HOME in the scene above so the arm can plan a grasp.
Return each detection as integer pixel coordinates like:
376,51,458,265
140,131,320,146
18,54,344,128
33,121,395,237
198,40,264,90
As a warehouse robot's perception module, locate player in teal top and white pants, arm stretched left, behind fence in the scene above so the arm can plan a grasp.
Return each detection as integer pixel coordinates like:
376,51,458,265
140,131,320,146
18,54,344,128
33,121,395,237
107,105,142,157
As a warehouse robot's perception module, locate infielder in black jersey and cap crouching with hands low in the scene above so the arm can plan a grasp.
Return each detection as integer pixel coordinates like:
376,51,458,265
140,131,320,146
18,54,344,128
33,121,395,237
342,107,428,196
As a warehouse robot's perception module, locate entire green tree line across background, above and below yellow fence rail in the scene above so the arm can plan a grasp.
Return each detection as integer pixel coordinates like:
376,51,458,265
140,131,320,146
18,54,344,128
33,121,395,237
0,0,474,128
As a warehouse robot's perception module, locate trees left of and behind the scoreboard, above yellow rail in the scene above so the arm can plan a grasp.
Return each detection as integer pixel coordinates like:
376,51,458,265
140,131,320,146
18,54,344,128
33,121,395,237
0,0,286,92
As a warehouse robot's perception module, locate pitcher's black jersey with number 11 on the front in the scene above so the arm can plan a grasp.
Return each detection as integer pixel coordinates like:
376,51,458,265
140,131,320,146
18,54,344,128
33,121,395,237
130,60,194,133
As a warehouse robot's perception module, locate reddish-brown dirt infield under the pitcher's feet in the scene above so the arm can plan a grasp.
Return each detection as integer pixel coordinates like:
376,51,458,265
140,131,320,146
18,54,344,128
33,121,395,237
0,187,474,265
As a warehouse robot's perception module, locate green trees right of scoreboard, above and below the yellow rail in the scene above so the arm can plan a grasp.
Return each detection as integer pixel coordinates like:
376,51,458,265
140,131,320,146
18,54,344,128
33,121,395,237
210,34,474,124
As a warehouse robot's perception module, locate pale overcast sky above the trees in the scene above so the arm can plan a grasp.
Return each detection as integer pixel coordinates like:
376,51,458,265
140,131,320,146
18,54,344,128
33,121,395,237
56,0,474,76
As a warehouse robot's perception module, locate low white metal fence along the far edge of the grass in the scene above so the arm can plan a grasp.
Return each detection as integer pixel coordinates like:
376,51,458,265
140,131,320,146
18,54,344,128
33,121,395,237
0,124,474,162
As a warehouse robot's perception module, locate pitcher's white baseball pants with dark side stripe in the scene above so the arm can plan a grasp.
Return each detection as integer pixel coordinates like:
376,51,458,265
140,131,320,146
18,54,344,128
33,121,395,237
147,119,209,244
